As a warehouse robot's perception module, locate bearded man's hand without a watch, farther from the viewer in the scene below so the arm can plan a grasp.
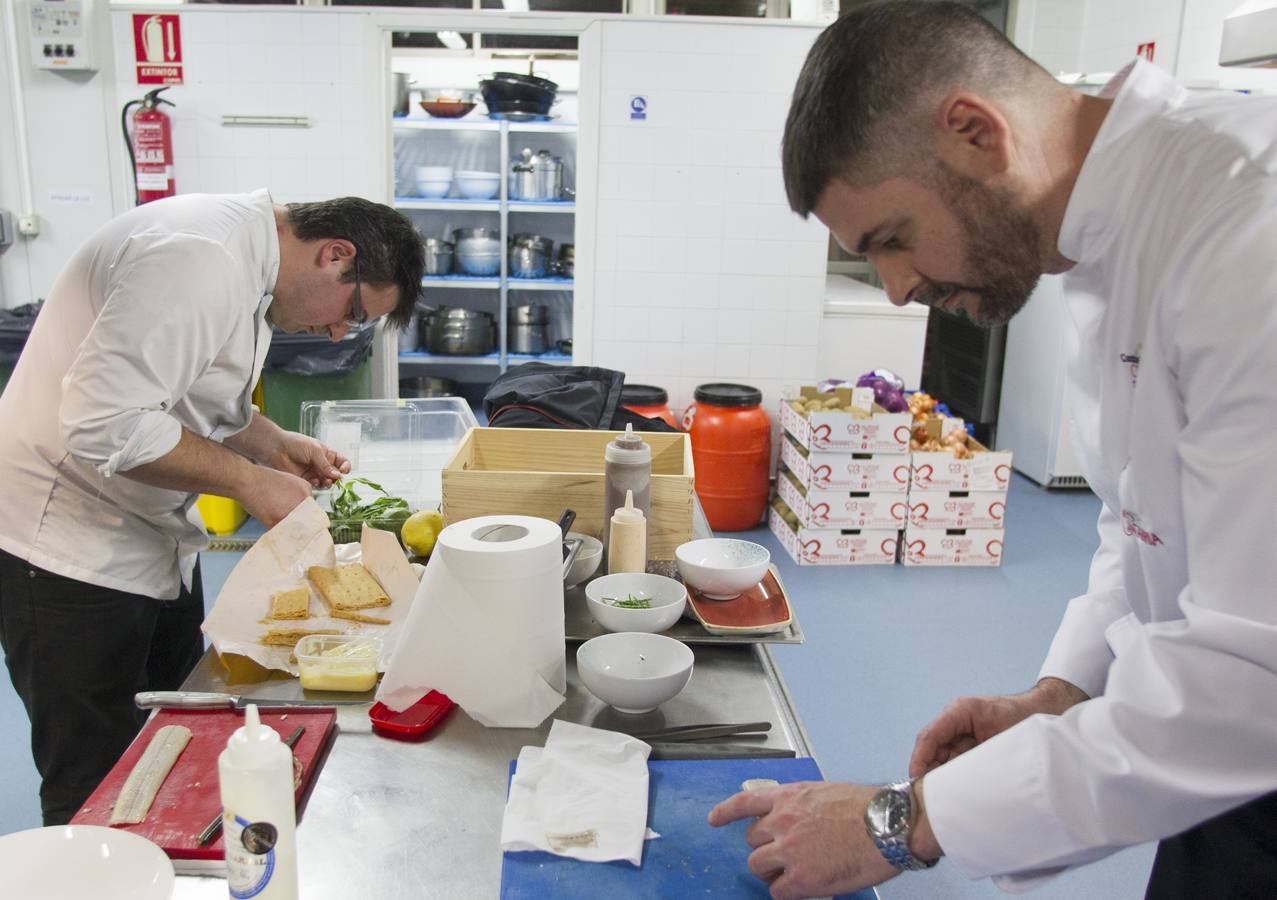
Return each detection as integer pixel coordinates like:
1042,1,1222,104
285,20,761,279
909,678,1088,777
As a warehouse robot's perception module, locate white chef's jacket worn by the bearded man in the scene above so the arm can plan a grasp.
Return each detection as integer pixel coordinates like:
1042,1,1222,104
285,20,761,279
925,61,1277,887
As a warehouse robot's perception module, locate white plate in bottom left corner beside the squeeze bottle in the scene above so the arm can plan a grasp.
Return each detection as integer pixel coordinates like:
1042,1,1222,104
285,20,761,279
0,825,174,900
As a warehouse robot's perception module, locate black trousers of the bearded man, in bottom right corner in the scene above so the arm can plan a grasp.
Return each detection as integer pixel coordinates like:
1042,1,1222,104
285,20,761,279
1144,793,1277,900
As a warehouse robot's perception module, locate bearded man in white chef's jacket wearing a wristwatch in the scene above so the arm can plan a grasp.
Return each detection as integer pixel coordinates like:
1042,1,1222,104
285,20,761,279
710,3,1277,897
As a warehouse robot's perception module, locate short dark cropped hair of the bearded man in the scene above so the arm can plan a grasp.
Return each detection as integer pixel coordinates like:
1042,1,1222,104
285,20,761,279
782,0,1050,217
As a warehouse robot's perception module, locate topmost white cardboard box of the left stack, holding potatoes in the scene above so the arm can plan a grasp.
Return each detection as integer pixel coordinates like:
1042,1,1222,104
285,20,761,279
780,387,913,453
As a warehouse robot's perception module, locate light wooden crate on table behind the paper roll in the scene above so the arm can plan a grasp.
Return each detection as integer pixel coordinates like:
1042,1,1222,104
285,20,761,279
443,428,695,559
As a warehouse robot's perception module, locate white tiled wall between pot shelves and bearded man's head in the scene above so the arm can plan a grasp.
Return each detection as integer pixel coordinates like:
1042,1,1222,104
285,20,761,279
593,20,827,439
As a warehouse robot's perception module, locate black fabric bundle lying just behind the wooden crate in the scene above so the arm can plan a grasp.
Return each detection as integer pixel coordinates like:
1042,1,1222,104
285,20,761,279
483,363,674,431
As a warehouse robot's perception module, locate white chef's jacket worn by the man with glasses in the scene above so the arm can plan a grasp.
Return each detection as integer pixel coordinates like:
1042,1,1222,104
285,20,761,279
0,190,280,599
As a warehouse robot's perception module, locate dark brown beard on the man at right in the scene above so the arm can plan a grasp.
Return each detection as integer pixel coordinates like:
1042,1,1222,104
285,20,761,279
914,163,1042,328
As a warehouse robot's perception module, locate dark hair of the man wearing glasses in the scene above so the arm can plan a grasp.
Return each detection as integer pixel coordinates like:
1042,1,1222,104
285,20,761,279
287,197,425,328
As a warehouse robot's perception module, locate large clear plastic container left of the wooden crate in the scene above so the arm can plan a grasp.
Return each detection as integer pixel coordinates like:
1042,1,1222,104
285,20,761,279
301,397,479,544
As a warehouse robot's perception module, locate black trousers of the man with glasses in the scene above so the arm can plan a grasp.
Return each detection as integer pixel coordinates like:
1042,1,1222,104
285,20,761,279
0,550,204,825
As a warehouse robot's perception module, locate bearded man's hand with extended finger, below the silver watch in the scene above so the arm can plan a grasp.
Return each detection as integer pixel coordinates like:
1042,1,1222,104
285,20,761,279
709,781,898,900
